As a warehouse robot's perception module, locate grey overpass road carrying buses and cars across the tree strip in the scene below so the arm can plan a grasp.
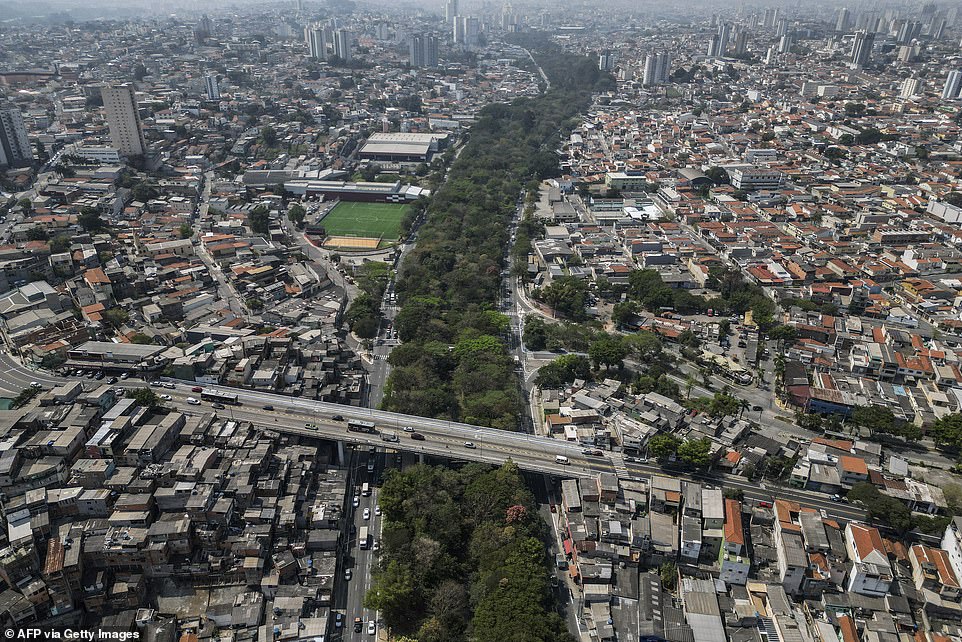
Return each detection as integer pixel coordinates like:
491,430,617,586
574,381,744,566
0,355,865,520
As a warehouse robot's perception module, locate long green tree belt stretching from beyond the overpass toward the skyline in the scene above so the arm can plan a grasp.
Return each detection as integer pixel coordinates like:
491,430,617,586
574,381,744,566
382,35,613,430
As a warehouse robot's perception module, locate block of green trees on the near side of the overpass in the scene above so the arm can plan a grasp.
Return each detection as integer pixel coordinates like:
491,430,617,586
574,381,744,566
365,462,570,642
